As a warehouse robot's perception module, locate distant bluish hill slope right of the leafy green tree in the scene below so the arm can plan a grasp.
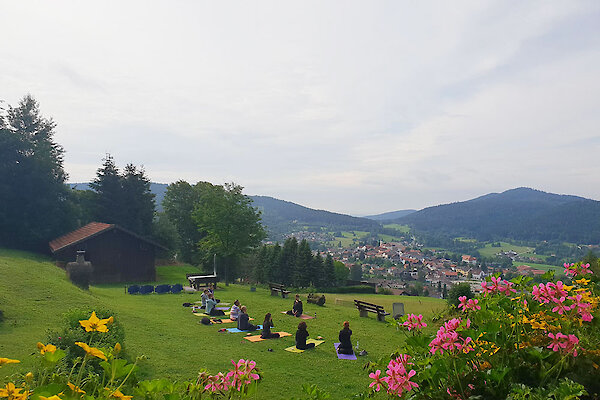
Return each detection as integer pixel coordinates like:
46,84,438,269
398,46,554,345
250,196,381,240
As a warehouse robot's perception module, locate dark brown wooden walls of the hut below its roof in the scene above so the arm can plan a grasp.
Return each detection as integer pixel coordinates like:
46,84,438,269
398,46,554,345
55,229,156,283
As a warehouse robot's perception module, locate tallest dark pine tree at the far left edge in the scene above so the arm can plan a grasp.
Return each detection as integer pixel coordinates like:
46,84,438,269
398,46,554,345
0,95,75,251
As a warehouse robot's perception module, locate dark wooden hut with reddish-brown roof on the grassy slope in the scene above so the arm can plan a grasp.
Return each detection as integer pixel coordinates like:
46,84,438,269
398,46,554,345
49,222,166,283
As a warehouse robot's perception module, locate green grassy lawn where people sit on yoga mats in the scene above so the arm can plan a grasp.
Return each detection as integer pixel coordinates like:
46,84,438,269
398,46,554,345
0,248,445,399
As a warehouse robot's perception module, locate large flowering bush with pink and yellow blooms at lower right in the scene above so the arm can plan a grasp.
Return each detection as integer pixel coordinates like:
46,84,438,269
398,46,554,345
366,263,600,400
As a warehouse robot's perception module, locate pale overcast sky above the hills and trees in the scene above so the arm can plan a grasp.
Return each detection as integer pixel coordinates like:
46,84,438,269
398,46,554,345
0,0,600,215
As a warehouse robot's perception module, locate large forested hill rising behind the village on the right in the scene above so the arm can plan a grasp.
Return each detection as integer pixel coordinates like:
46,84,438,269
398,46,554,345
394,188,600,244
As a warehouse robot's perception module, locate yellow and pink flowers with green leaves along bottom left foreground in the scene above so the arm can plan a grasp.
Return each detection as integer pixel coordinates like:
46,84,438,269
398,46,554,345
0,312,260,400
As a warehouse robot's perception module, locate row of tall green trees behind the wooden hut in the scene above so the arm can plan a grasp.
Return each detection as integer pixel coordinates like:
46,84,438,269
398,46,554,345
0,95,265,277
